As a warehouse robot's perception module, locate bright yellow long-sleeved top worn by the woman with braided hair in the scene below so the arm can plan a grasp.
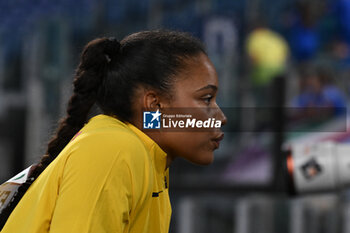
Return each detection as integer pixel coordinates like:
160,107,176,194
1,115,171,233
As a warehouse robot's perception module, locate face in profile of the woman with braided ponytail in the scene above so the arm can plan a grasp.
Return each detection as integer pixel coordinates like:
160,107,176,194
152,54,226,165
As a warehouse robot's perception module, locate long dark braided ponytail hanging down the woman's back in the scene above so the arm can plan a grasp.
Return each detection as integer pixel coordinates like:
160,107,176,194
0,38,120,225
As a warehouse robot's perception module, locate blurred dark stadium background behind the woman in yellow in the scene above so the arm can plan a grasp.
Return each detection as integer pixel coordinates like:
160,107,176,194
0,0,350,233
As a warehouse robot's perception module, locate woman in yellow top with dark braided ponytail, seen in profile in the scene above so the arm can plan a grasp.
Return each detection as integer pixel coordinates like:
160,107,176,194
1,31,226,233
